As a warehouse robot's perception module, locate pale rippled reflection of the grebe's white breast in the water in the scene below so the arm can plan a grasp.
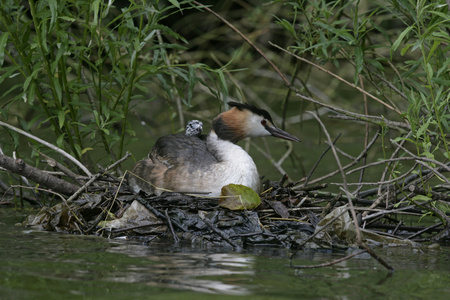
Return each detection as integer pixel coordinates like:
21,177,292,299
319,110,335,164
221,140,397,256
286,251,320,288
105,243,254,295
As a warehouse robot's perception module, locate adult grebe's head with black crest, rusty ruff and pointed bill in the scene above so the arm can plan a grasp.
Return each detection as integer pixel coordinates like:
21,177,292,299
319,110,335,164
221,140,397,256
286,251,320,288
212,102,300,143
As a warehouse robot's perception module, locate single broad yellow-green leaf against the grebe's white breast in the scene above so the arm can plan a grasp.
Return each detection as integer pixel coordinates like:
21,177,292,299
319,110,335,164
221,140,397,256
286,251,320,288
219,184,261,210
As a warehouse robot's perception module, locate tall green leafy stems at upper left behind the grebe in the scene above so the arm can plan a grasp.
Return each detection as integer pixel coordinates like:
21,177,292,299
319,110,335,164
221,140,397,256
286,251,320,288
0,0,221,167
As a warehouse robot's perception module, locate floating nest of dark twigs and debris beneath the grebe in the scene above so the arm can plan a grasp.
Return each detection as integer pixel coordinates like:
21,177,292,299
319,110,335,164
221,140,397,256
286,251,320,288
25,171,448,250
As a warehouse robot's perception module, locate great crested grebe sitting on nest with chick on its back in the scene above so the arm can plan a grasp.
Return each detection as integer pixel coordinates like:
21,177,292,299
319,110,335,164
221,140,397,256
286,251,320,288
128,102,300,197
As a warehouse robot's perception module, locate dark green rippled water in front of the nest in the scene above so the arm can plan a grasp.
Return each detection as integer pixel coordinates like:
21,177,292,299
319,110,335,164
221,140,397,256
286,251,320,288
0,208,450,300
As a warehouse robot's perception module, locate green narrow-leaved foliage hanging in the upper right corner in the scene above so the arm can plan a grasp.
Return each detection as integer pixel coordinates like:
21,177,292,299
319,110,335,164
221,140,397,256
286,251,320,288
278,0,450,158
